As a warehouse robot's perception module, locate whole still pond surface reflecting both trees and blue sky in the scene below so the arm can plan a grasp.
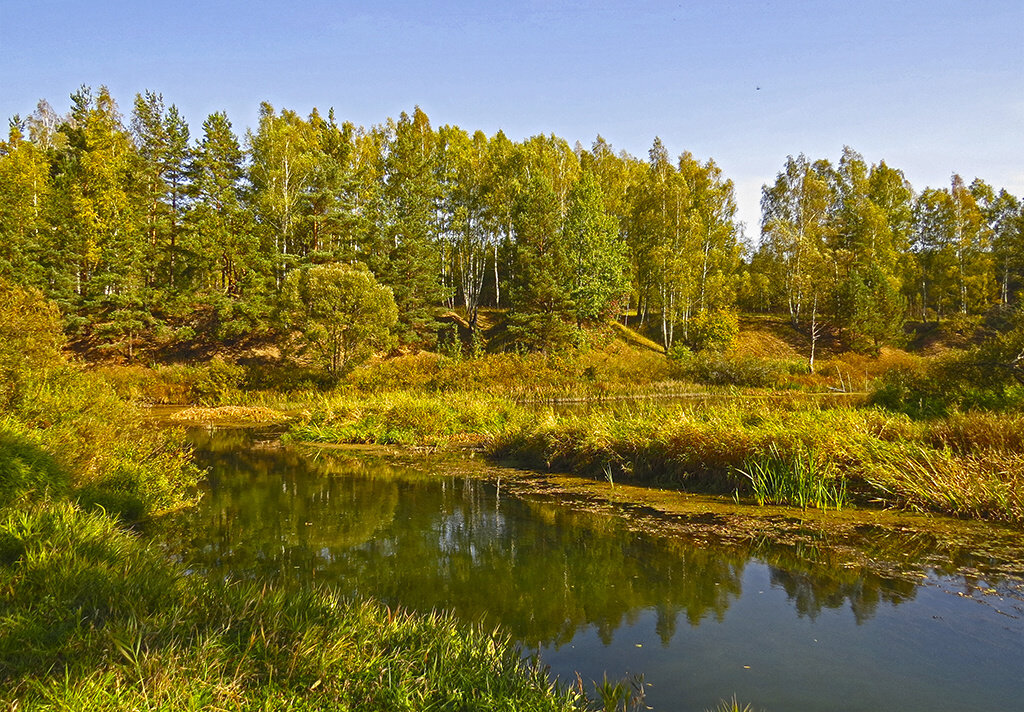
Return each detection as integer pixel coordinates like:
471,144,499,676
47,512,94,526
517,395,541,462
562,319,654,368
171,431,1024,712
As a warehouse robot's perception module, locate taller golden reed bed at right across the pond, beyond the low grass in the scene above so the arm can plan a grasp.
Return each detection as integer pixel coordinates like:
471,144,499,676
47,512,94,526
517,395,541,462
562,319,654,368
486,403,1024,523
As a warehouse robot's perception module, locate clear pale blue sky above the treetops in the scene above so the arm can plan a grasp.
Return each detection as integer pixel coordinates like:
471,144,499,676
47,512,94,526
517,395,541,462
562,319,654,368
0,0,1024,237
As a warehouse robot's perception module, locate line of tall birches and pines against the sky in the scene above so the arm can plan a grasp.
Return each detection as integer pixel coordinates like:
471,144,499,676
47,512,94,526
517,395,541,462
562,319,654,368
0,87,1024,358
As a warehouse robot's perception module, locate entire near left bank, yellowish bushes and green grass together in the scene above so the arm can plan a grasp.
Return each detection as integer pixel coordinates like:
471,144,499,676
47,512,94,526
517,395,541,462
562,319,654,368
0,284,589,710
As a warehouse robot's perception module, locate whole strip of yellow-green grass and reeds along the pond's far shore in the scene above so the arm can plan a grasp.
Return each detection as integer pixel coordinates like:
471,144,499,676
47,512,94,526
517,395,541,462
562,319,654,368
290,392,1024,525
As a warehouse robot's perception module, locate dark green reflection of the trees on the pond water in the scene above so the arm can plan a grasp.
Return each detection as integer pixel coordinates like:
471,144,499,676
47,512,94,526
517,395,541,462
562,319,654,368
180,434,974,645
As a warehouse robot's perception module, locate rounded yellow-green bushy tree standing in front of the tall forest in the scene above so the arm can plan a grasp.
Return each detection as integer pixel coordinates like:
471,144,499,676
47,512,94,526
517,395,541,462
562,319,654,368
282,265,397,375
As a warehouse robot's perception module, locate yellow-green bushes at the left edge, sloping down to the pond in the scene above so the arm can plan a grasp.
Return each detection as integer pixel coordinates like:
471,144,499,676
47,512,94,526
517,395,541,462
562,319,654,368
0,290,200,519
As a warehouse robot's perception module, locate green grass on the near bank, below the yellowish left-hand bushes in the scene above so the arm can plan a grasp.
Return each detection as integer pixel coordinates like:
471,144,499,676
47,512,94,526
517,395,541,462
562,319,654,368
0,502,585,710
